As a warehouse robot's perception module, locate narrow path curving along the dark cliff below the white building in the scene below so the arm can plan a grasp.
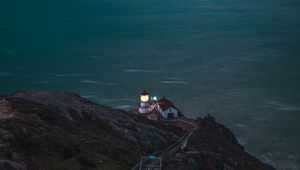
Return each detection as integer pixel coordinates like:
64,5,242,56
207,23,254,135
131,119,198,170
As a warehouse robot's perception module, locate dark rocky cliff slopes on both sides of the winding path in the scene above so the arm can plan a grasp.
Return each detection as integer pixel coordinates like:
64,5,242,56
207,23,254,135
0,90,274,170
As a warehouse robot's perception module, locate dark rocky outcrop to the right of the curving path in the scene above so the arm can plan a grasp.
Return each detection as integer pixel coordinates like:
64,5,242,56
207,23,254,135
165,114,274,170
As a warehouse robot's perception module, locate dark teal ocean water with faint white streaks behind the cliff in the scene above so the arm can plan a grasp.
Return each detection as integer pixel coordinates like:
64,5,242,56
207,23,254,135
0,0,300,170
